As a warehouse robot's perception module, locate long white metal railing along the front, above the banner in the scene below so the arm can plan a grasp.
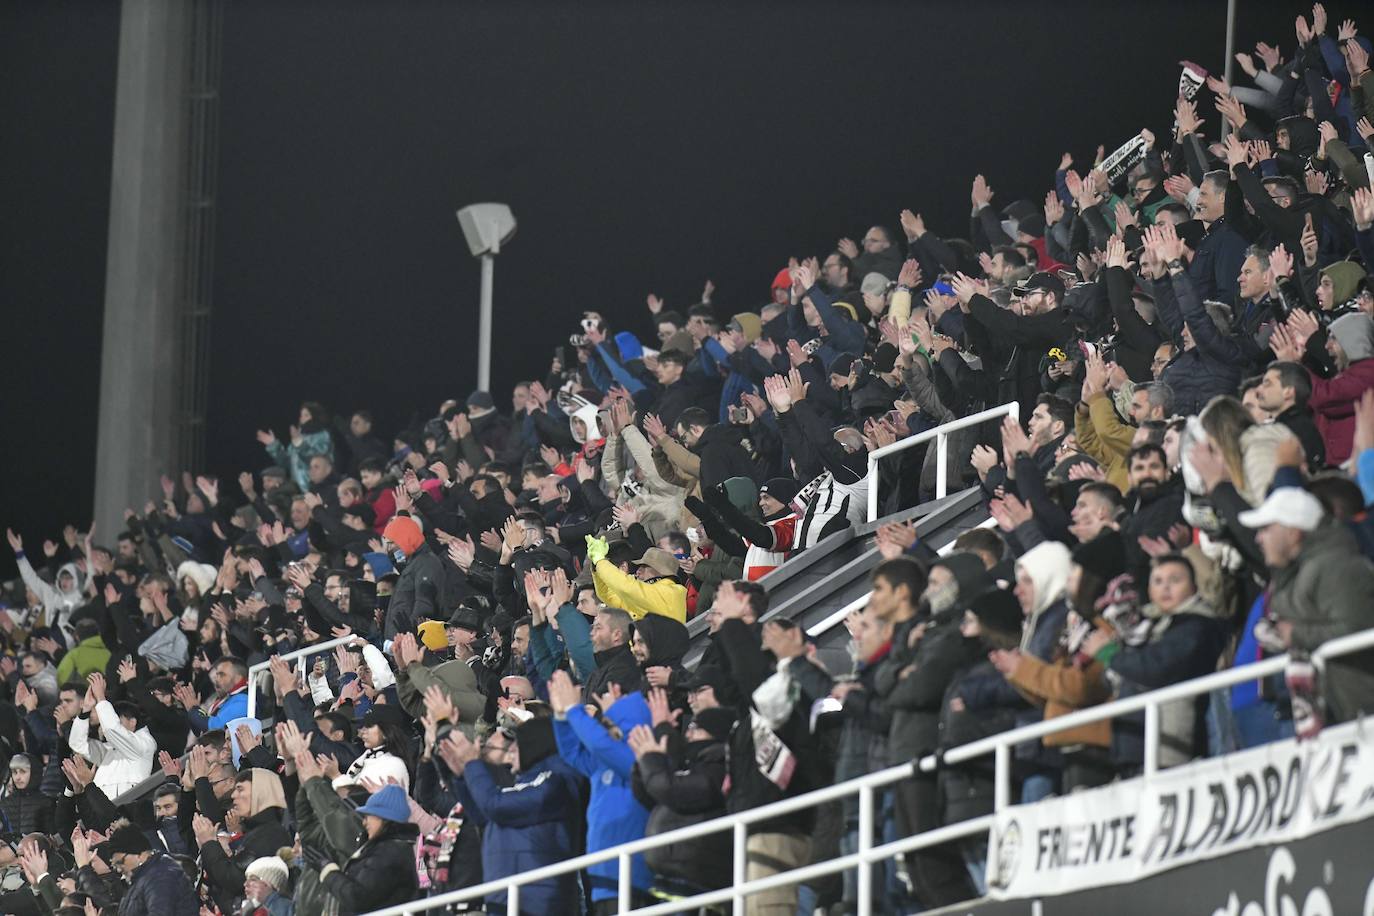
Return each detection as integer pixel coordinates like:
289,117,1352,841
374,620,1374,916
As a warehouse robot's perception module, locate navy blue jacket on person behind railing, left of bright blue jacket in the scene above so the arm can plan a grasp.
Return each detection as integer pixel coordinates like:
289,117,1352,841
463,754,581,913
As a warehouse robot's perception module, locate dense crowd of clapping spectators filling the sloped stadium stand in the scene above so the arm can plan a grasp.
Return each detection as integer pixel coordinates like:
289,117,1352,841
0,4,1374,916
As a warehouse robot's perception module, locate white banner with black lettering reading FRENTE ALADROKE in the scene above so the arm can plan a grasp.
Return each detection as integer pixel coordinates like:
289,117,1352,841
988,722,1374,900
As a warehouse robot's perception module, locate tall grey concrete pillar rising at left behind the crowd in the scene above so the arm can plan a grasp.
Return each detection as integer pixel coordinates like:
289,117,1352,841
95,0,190,547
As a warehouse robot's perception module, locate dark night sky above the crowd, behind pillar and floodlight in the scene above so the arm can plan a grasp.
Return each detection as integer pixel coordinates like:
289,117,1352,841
8,0,1297,560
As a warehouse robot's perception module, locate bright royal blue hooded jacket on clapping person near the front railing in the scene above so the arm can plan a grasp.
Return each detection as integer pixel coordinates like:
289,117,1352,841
554,692,653,901
